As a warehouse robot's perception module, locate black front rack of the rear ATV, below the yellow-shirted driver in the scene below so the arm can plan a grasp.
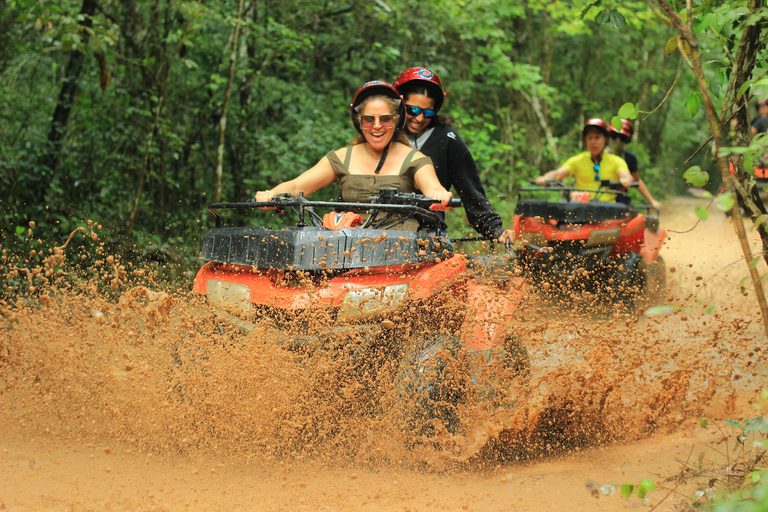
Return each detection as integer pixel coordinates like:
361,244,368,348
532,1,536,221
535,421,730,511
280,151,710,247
515,199,637,224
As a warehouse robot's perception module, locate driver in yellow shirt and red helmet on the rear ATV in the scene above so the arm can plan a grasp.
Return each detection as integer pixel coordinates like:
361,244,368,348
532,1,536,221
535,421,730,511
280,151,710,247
536,118,632,202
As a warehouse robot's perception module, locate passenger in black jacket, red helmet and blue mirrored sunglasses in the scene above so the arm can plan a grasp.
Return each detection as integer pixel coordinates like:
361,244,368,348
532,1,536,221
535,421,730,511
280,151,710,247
394,67,514,242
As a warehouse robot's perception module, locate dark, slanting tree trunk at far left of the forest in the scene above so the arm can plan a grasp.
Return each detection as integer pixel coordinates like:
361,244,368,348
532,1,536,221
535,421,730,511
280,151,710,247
41,0,96,206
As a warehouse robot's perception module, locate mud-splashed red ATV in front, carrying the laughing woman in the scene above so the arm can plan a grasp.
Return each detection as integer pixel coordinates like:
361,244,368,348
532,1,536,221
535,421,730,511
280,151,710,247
194,189,528,446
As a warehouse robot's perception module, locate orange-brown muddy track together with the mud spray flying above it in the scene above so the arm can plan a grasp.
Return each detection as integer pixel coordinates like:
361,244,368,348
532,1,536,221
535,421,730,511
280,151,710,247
0,200,768,510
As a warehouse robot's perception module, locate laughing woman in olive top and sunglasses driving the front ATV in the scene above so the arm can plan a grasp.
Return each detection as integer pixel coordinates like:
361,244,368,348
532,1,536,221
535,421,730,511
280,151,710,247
256,80,452,230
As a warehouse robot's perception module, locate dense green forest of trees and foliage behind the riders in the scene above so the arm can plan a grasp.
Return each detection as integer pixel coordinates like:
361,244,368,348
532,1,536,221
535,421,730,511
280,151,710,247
0,0,768,260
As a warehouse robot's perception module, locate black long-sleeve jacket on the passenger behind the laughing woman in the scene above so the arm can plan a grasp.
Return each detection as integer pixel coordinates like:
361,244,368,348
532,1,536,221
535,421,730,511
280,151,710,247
416,125,503,239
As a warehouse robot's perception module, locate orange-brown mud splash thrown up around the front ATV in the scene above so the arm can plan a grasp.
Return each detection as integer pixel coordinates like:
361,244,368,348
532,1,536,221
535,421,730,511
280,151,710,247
0,197,766,509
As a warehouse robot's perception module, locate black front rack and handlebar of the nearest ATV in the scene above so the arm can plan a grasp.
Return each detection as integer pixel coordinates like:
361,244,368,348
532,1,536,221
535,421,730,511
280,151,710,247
201,194,456,271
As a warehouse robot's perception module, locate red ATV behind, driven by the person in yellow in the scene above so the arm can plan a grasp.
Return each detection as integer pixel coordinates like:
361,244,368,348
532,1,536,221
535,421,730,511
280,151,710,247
514,181,666,307
